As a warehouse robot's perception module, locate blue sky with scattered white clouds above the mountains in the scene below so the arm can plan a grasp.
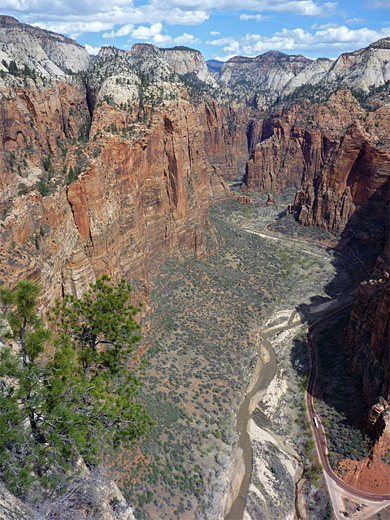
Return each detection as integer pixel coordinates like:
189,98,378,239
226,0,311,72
0,0,390,61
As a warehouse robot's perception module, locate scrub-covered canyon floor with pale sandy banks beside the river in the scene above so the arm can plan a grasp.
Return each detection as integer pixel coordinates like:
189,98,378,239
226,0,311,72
106,189,387,520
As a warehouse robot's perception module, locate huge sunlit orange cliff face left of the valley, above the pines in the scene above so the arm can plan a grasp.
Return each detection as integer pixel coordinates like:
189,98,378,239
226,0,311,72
0,92,208,303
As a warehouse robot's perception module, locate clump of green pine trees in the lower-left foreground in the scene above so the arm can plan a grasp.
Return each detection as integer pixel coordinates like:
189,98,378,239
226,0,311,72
0,276,151,495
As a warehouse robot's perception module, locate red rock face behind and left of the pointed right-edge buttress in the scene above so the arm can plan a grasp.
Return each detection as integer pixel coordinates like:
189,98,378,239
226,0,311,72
244,91,365,195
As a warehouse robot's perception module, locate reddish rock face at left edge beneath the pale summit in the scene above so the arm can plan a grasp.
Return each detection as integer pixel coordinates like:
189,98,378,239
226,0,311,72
0,77,89,204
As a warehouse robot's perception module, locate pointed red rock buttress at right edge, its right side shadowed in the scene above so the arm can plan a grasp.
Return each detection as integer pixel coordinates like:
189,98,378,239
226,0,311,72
294,119,390,235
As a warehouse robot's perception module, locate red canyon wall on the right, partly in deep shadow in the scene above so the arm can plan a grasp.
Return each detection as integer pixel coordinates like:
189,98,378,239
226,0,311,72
244,90,390,418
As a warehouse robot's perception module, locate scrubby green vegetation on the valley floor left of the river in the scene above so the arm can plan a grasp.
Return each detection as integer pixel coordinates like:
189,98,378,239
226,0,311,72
113,194,342,519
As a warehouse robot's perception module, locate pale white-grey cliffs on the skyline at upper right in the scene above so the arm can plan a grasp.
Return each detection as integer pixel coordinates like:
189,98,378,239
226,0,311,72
218,38,390,106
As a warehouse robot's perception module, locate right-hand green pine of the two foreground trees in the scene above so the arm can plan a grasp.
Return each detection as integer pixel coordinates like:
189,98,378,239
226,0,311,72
50,275,151,464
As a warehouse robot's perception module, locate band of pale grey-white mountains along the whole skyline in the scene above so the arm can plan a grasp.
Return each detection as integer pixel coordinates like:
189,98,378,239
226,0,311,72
0,16,390,107
